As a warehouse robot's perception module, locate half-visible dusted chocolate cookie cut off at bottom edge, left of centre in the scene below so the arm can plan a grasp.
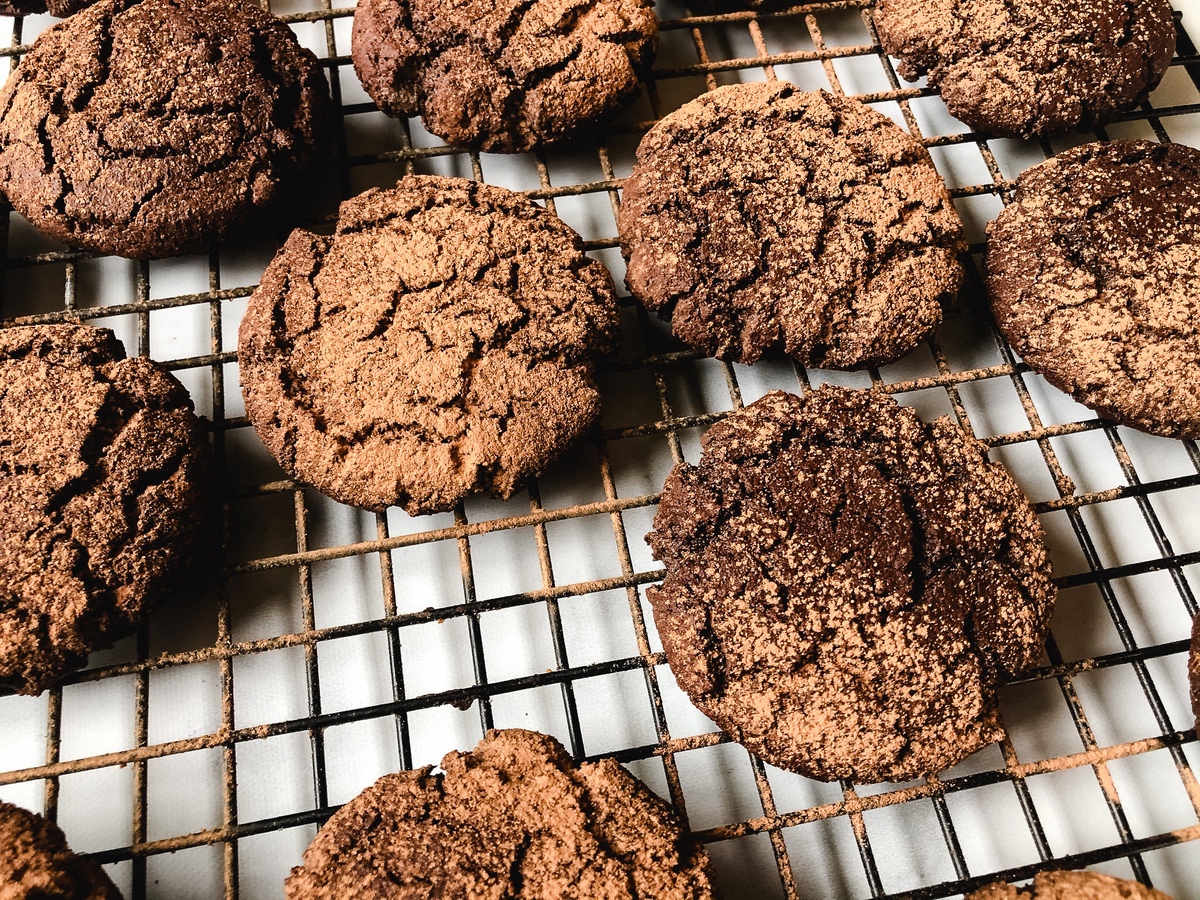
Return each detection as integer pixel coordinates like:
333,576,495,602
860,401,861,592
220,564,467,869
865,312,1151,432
284,731,713,900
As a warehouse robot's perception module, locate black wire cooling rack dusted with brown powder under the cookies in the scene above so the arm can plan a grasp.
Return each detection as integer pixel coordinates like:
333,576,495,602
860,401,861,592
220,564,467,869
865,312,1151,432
0,0,1200,898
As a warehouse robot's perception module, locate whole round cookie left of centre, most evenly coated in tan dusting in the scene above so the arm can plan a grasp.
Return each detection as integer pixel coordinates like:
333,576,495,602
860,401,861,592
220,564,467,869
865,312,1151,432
239,176,617,515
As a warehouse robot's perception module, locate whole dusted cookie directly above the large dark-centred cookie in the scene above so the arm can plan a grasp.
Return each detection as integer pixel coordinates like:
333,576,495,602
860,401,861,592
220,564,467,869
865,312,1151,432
617,83,966,368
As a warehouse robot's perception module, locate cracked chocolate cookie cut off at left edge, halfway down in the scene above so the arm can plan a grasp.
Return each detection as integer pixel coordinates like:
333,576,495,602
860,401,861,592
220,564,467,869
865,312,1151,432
0,325,209,694
